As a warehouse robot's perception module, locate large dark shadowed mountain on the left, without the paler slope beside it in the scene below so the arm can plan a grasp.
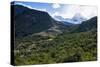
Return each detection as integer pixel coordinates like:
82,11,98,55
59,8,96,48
11,5,55,36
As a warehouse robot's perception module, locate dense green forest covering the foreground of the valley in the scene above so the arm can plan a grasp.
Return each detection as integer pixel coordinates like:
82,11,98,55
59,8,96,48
15,27,97,65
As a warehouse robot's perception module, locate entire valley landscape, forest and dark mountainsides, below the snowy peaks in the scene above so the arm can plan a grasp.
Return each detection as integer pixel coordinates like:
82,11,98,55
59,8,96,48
11,5,97,65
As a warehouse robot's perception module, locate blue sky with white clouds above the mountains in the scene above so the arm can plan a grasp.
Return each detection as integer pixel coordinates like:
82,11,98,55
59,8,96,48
15,1,97,19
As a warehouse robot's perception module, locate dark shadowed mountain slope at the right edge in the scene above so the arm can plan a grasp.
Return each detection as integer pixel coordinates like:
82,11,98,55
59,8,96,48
74,16,97,32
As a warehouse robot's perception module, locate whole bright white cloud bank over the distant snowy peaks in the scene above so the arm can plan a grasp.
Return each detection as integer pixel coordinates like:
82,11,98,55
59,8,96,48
52,5,97,19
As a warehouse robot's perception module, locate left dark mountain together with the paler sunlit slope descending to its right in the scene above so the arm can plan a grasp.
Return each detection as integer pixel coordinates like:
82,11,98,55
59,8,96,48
11,5,69,37
